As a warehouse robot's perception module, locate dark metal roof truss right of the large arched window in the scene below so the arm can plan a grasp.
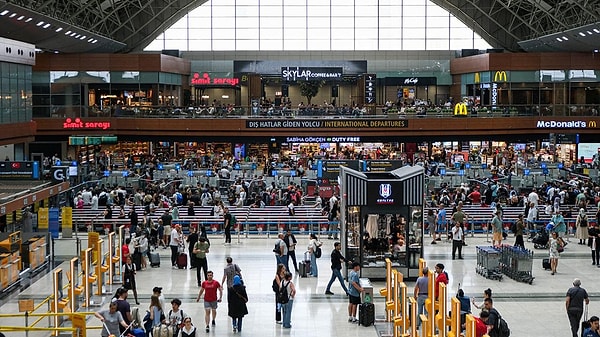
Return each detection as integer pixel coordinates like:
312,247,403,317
432,0,600,51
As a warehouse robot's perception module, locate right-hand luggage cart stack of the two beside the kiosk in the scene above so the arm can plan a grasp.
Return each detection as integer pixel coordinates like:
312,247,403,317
500,246,535,284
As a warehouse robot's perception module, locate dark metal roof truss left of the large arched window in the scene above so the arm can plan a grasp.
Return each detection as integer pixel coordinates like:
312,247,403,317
7,0,206,53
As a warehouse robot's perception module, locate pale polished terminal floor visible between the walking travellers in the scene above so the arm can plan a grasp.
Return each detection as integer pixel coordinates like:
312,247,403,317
0,234,600,337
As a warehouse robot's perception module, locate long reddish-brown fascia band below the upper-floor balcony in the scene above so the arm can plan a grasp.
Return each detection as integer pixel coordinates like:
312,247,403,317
36,117,600,139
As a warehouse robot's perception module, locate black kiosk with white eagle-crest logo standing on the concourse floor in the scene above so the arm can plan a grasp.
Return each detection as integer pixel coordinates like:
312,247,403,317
339,166,425,280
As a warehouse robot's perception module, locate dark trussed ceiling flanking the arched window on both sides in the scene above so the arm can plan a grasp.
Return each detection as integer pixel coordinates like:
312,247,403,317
0,0,600,53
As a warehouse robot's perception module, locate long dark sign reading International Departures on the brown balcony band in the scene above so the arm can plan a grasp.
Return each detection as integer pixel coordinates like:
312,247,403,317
246,119,408,129
